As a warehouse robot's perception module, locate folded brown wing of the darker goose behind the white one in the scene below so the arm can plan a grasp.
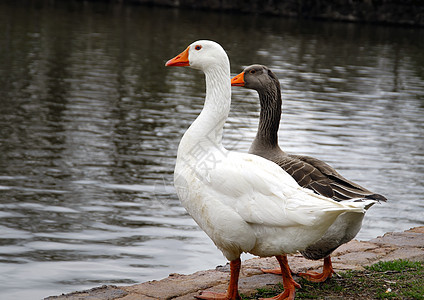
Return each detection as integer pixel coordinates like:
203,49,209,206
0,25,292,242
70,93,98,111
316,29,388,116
273,153,387,201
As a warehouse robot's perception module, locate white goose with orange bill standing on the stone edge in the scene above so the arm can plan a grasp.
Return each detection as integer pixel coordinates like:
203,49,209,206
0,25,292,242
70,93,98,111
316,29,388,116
166,40,375,299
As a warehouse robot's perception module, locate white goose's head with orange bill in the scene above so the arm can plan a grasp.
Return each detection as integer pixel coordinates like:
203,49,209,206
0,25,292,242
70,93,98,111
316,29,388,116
165,40,230,71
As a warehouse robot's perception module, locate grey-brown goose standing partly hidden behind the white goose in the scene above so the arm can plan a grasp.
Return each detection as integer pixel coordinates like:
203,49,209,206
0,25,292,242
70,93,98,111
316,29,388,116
231,65,387,282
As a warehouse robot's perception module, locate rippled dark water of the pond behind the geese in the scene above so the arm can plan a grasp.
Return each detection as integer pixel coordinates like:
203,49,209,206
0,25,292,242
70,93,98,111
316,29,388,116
0,1,424,299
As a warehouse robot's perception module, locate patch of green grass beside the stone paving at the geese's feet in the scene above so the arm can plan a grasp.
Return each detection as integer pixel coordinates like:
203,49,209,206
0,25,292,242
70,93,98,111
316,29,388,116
243,259,424,300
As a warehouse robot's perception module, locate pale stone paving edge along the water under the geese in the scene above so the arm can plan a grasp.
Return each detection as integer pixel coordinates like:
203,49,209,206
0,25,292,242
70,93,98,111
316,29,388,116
45,226,424,300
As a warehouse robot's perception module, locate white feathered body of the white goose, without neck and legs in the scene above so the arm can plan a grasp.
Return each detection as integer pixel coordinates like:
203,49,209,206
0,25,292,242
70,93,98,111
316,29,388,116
175,143,372,260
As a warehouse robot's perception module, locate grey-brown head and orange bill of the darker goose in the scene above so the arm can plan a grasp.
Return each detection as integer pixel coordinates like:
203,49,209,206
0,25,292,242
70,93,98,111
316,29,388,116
231,65,280,92
